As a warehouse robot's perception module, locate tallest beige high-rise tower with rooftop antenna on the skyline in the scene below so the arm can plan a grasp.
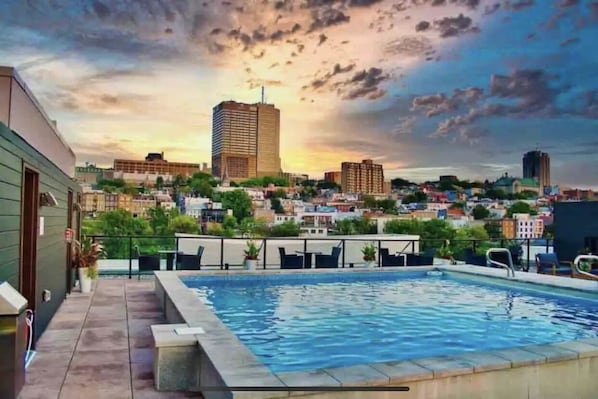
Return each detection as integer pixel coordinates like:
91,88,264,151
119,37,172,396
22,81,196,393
212,101,281,180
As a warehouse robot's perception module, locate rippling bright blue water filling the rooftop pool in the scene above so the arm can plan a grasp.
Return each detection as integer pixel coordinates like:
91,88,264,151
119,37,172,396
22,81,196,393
183,272,598,372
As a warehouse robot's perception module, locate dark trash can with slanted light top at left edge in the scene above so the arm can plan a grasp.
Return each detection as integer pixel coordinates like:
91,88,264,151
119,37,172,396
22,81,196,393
0,282,27,398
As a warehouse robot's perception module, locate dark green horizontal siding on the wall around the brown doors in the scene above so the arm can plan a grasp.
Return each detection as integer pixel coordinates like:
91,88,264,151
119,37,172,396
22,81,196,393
0,123,80,338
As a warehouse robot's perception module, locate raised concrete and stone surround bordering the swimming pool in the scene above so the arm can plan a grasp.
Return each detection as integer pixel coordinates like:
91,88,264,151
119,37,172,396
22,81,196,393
156,265,598,399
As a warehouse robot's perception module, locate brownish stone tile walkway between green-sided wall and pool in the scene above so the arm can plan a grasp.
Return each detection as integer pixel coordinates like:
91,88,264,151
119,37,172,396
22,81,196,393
19,279,201,399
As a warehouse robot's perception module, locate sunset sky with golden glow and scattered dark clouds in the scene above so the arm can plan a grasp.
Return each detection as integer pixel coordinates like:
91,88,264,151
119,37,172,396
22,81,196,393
0,0,598,187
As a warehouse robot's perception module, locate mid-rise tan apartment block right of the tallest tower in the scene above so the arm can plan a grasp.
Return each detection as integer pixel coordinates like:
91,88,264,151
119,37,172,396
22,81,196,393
341,159,384,194
